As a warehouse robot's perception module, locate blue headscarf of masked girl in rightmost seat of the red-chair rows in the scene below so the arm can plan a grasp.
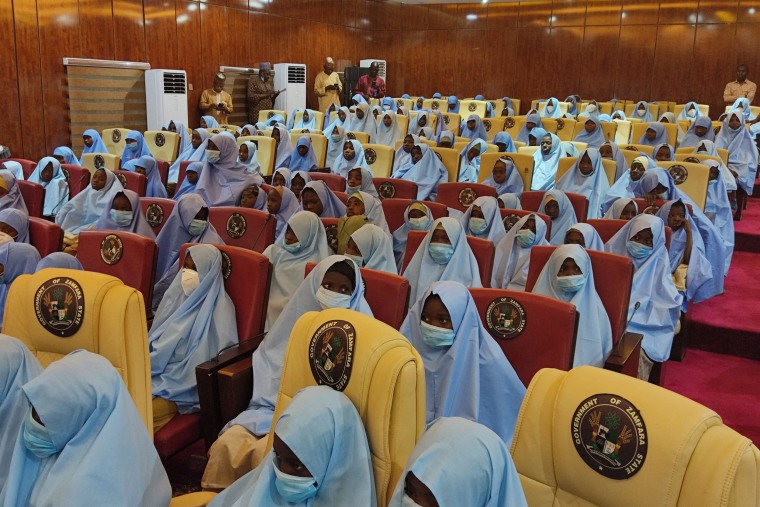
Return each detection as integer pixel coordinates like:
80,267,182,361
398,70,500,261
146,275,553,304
604,215,682,362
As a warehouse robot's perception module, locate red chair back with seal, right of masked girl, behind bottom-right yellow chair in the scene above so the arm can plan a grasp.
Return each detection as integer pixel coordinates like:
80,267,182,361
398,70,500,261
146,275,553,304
470,289,578,386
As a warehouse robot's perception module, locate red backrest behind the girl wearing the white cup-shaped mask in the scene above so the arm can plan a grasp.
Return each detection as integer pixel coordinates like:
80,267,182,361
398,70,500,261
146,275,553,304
179,243,272,342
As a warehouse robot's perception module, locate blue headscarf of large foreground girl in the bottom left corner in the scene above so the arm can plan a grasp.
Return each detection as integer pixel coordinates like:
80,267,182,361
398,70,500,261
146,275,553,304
0,350,172,505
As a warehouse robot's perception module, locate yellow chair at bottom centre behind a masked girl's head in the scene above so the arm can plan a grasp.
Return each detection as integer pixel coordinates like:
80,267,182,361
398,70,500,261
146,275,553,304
268,309,425,505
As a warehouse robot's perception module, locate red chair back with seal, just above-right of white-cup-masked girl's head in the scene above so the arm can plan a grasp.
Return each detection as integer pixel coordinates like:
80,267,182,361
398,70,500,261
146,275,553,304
209,206,277,252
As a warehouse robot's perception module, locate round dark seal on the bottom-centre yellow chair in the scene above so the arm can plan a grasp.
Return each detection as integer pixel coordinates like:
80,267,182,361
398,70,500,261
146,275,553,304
309,320,356,391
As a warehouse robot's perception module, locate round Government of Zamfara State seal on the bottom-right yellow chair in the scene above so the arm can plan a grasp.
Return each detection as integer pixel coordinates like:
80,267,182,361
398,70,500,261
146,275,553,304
570,394,649,480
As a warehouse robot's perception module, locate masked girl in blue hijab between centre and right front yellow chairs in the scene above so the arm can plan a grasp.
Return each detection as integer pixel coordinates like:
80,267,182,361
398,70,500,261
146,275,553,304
400,281,525,444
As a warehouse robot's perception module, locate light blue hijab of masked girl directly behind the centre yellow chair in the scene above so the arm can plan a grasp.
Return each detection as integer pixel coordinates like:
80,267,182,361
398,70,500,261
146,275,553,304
229,255,374,436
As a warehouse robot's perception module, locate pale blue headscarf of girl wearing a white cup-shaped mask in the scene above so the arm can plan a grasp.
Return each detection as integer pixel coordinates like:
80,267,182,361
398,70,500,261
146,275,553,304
148,245,242,414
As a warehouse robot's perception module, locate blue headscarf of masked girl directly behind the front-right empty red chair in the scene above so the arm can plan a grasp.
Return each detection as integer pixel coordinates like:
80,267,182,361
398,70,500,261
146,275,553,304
532,245,612,368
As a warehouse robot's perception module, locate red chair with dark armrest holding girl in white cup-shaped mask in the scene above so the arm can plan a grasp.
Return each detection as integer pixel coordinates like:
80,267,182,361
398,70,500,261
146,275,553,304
153,244,272,459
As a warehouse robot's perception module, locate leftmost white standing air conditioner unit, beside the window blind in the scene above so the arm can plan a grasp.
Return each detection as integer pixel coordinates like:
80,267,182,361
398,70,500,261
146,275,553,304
145,69,187,130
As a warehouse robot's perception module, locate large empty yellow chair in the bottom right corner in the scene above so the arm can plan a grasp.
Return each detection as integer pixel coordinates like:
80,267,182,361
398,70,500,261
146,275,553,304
511,366,760,507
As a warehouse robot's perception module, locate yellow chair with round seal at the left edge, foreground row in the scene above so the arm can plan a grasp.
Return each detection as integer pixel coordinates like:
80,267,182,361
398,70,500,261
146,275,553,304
3,268,153,437
